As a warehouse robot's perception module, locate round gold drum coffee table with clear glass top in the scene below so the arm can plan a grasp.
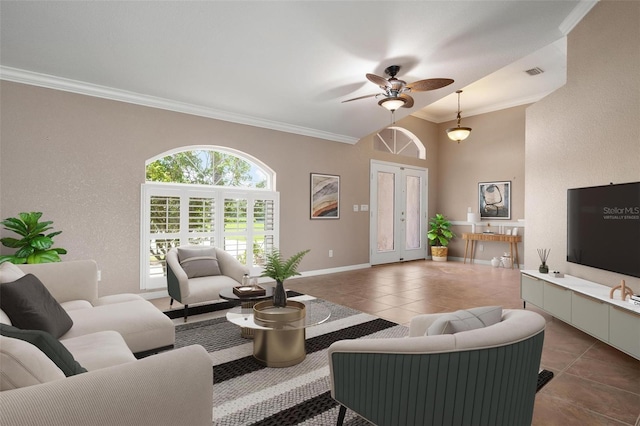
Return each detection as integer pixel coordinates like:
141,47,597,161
227,299,331,367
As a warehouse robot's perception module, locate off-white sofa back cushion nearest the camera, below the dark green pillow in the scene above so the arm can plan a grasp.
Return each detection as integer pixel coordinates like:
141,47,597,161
0,335,65,391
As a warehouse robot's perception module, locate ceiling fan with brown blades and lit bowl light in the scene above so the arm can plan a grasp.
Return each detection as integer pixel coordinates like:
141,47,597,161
342,65,453,112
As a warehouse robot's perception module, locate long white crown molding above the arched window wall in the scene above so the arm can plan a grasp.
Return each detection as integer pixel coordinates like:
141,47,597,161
0,66,360,145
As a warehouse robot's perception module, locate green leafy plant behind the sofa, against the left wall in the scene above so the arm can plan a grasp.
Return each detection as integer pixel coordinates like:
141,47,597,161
0,212,67,264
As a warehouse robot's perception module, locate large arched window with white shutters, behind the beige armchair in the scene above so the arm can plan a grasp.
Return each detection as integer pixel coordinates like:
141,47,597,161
141,146,279,290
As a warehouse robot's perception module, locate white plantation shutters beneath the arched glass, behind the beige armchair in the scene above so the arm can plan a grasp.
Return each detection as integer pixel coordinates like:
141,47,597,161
140,182,279,290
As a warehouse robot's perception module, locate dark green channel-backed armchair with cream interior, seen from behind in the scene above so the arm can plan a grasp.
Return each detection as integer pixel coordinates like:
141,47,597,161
328,310,545,426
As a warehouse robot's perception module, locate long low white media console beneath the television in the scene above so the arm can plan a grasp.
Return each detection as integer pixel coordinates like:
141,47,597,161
520,270,640,359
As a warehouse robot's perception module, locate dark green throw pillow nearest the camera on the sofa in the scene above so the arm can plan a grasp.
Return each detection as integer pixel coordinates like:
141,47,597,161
0,324,87,377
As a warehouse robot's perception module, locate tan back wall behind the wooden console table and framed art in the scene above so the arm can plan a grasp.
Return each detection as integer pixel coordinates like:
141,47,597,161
435,105,527,262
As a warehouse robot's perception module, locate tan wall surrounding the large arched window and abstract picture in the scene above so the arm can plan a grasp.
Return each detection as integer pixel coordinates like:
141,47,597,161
0,81,437,294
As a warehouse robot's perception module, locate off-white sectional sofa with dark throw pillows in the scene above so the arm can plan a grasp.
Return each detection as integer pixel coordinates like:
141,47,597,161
0,261,213,425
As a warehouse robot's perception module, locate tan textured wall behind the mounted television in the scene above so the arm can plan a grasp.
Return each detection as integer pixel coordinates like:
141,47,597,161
525,1,640,293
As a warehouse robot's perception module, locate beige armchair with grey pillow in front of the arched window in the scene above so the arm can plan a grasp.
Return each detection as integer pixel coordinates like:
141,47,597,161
167,245,249,322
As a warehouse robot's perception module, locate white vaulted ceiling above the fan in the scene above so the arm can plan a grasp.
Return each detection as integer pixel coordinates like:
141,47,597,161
0,0,595,143
